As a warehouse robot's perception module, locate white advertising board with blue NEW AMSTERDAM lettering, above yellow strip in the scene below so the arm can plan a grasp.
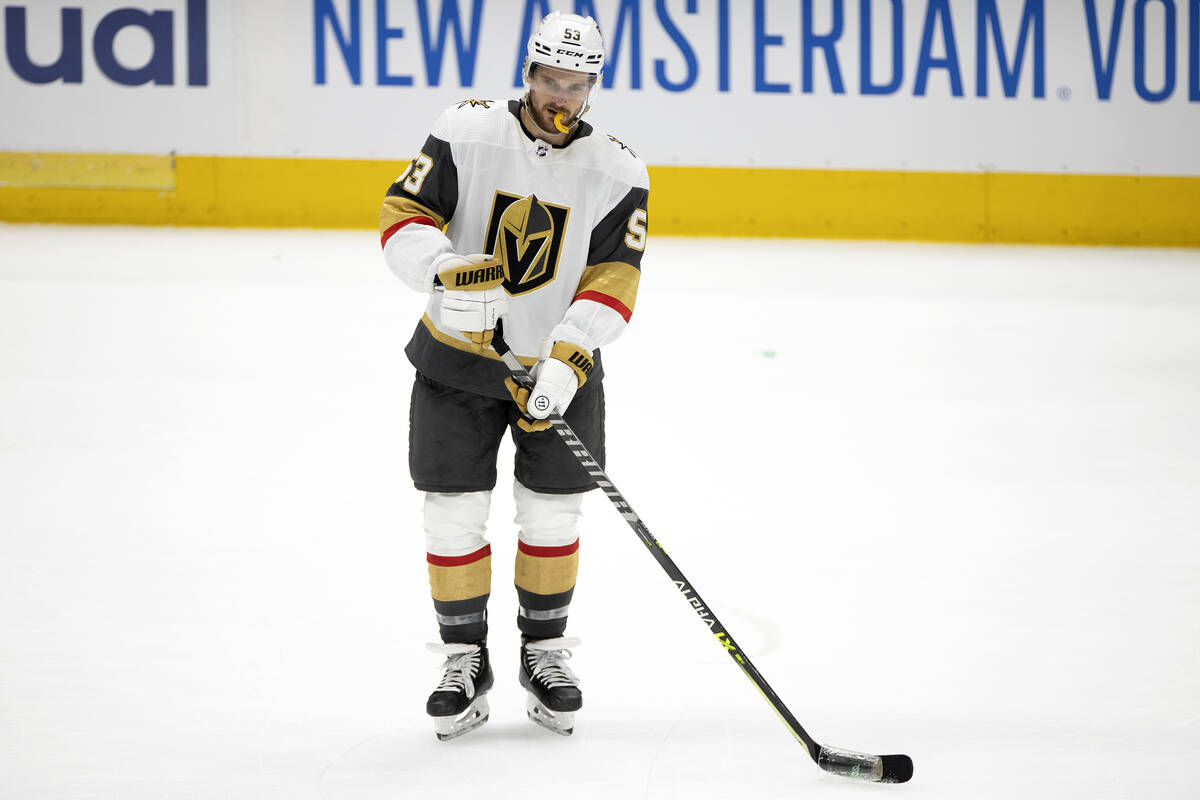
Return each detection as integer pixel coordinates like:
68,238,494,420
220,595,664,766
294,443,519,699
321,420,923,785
0,0,1200,176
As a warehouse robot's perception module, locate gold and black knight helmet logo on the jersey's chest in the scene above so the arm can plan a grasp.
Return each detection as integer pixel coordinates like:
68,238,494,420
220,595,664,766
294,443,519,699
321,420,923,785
484,192,571,295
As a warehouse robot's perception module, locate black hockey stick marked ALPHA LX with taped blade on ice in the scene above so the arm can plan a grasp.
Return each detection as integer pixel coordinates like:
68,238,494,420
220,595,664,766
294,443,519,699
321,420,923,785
492,320,912,783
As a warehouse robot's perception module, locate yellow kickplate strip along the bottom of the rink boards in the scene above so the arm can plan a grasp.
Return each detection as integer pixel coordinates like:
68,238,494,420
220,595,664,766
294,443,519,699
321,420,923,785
0,154,1200,247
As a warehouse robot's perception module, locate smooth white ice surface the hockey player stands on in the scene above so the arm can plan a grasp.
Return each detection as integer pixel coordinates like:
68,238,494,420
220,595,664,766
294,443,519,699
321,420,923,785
0,220,1200,800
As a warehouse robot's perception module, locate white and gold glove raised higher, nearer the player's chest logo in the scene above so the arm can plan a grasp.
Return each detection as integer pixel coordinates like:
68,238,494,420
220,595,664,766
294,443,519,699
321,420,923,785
433,253,509,354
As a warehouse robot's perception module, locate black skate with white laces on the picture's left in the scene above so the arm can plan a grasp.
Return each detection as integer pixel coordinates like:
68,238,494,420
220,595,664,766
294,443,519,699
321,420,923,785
425,643,493,741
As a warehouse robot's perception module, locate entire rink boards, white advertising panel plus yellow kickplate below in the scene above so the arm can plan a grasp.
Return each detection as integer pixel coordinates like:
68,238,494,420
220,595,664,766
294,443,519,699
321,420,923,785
0,0,1200,246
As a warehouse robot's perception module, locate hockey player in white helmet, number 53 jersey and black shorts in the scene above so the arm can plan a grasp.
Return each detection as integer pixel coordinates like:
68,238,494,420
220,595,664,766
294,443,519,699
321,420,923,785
379,12,649,739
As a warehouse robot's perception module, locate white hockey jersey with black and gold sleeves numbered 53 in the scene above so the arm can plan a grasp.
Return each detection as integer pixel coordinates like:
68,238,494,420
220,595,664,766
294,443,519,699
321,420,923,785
379,101,649,398
